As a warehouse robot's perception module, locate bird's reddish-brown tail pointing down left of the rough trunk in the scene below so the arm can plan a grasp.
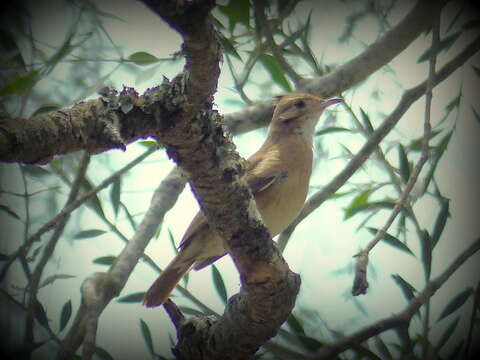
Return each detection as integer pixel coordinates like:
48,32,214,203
143,251,195,307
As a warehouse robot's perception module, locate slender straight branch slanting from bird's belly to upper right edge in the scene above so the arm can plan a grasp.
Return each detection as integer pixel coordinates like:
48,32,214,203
278,37,480,249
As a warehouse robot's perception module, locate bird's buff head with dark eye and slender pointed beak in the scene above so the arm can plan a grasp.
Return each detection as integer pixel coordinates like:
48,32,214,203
269,93,343,142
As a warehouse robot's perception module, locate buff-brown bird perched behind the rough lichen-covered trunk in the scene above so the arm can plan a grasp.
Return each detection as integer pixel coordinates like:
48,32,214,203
143,93,342,307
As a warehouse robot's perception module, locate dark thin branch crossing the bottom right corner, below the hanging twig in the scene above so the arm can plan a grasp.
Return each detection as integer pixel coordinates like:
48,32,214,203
309,238,480,360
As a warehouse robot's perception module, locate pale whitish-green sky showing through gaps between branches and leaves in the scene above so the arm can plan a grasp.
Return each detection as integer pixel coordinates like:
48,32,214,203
0,0,480,359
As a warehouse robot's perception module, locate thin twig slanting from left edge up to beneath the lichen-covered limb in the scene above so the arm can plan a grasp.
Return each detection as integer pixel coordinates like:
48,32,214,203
0,147,157,282
